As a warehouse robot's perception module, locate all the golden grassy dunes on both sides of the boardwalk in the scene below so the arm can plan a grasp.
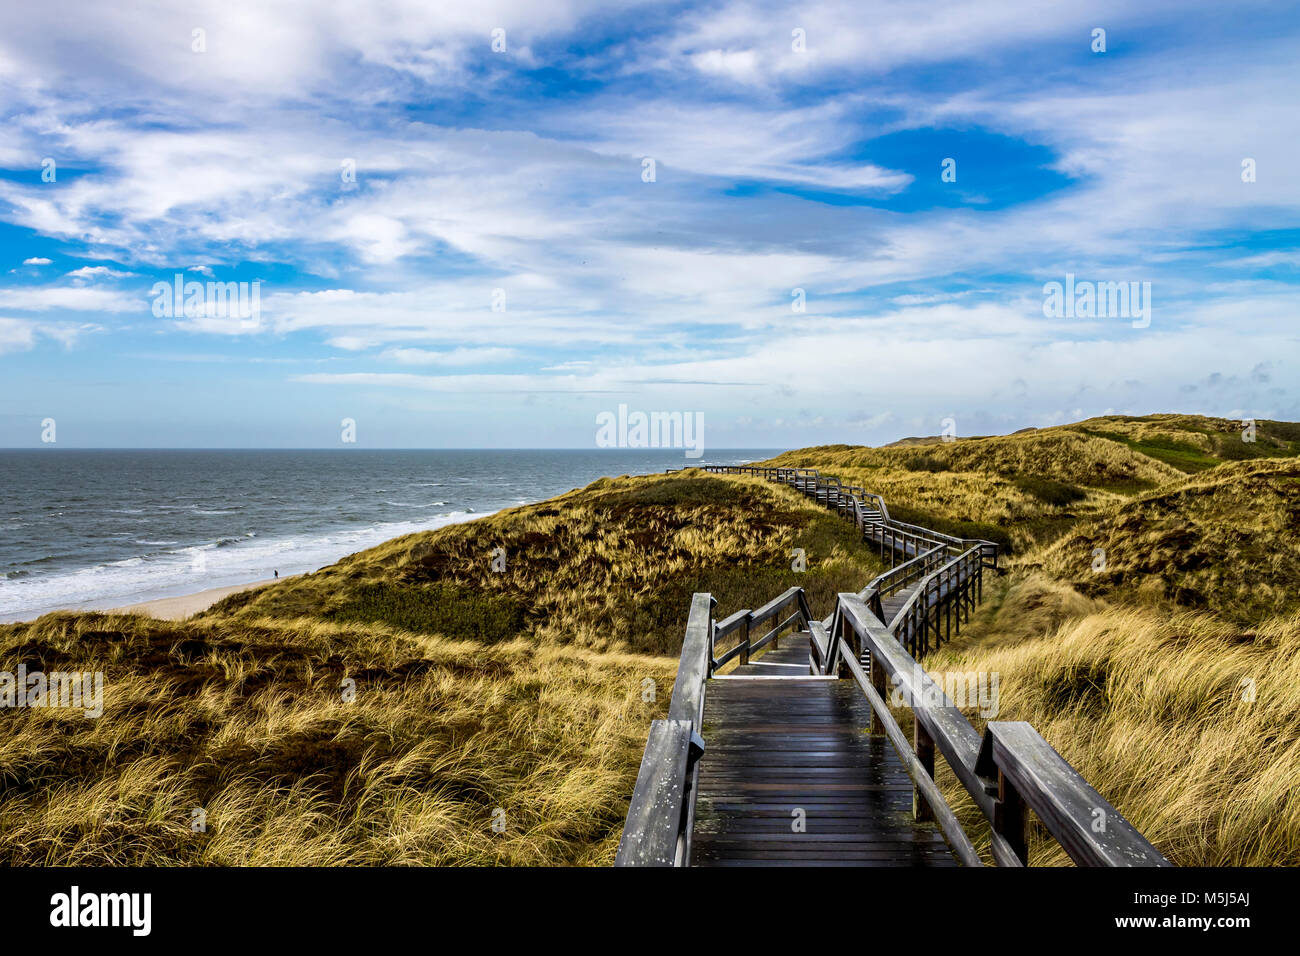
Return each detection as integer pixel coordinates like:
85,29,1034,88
0,415,1300,865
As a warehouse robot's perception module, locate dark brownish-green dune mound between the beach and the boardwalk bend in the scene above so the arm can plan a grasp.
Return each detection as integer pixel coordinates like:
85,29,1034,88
212,471,880,654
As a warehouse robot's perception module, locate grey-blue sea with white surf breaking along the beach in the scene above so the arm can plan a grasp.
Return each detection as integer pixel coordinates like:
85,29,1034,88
0,447,777,623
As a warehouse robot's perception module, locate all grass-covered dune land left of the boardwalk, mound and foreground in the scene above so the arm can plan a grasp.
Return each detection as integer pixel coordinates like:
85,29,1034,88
0,472,879,865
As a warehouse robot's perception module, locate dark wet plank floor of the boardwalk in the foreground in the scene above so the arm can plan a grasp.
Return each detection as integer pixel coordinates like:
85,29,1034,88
692,681,957,866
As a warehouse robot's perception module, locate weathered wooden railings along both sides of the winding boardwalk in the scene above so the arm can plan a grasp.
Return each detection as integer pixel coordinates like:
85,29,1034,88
615,466,1170,866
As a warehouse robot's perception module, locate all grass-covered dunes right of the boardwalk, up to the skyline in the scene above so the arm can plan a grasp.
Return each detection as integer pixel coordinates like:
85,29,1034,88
759,415,1300,866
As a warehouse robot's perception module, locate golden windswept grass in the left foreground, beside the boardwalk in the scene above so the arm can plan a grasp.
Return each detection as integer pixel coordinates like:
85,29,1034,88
0,614,676,865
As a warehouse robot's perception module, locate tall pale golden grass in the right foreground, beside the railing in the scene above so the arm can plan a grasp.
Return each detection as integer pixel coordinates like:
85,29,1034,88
926,575,1300,866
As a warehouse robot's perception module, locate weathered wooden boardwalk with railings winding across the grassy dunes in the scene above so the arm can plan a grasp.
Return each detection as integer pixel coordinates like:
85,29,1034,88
616,466,1169,866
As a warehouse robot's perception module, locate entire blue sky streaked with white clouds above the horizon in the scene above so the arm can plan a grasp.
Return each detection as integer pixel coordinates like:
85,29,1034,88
0,0,1300,447
